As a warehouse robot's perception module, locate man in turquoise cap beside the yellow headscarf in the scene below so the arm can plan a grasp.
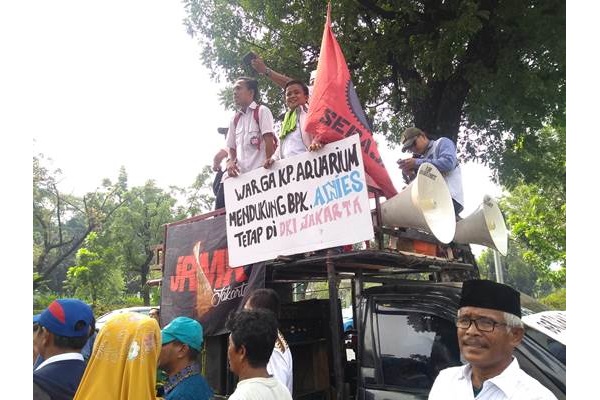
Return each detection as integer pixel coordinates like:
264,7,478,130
158,317,213,400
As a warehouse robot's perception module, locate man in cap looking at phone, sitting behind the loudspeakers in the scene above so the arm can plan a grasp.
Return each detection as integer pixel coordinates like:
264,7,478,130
397,127,464,216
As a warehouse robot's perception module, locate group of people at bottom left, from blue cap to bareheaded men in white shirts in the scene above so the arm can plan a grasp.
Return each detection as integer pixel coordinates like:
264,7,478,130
33,289,293,400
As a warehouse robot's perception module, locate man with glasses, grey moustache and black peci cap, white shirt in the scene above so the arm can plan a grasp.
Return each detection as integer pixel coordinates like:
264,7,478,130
429,280,556,400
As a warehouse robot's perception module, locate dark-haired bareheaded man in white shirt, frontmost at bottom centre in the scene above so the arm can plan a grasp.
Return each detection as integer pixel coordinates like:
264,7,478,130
225,309,292,400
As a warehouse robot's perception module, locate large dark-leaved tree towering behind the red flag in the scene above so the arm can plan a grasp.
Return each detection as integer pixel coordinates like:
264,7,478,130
184,0,566,165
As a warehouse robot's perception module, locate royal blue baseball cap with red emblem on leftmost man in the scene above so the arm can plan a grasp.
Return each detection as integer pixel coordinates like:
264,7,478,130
33,299,94,337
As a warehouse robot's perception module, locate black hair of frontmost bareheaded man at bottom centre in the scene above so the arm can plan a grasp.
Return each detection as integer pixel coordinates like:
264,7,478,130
225,309,277,368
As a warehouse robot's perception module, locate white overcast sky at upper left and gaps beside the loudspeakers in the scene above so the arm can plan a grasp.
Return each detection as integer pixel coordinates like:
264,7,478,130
27,1,501,216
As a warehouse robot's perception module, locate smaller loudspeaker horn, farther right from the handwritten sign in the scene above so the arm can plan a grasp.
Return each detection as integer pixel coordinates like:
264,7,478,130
454,195,508,256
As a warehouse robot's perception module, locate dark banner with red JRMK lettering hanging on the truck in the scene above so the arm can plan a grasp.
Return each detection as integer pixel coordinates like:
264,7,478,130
161,215,265,336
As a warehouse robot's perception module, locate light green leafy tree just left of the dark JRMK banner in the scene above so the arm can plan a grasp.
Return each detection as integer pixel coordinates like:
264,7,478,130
109,180,176,305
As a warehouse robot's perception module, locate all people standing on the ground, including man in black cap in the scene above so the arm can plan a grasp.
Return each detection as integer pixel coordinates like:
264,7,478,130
33,280,556,400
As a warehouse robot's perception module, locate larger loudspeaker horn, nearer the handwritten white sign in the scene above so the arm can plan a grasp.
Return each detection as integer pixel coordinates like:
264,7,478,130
381,163,456,243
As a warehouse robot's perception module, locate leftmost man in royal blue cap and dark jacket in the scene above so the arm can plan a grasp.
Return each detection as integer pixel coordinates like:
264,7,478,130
33,299,94,400
